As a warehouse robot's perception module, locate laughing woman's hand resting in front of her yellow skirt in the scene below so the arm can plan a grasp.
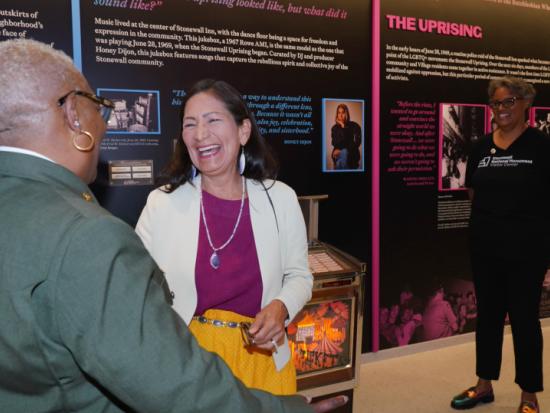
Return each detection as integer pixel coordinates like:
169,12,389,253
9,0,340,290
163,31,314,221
248,300,288,351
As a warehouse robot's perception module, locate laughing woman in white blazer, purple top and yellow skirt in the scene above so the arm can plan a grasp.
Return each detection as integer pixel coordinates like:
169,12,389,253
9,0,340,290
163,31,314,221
136,80,313,394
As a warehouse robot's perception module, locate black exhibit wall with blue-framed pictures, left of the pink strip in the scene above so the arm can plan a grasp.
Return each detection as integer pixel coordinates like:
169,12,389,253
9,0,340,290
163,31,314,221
0,0,372,344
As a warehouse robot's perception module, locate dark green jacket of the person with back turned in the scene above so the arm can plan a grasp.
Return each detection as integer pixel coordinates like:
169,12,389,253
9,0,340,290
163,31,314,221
0,151,311,413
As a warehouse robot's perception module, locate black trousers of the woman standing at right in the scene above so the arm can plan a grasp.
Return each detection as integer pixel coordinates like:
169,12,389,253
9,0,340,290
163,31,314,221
472,253,546,393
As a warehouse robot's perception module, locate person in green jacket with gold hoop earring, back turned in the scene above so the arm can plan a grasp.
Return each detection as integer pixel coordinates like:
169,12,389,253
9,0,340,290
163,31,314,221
0,39,345,413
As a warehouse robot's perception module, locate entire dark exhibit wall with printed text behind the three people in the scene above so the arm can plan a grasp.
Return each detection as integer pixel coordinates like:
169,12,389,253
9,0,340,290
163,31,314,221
4,0,550,352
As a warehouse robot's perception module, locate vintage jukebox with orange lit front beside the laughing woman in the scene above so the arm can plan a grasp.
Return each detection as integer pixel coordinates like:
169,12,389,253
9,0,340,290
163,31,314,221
294,195,366,406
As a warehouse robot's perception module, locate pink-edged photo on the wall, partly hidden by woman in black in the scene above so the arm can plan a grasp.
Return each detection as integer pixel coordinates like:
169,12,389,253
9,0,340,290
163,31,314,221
439,103,486,191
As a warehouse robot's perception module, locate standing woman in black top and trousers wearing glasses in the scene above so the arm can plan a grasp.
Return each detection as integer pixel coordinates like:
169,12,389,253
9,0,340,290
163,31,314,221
451,77,550,413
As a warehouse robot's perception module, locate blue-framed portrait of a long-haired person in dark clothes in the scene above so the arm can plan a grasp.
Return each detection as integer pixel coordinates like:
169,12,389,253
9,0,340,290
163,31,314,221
322,99,365,172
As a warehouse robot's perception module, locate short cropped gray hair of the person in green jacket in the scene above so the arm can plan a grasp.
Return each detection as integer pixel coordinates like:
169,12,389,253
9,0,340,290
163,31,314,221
0,39,83,143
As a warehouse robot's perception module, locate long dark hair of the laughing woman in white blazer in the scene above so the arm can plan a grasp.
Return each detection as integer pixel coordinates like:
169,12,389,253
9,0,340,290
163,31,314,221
158,79,279,193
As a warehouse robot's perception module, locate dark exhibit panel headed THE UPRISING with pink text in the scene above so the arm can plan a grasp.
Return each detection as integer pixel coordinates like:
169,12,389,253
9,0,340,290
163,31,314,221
375,0,550,348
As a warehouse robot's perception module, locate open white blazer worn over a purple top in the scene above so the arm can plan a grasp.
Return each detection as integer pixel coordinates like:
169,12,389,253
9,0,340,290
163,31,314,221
136,175,313,370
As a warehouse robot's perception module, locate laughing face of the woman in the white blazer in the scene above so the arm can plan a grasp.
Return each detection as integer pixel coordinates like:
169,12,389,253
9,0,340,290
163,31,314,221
182,92,250,182
